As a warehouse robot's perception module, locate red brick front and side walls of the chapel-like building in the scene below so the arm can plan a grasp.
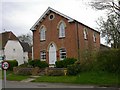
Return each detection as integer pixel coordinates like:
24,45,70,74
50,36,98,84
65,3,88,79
33,12,100,62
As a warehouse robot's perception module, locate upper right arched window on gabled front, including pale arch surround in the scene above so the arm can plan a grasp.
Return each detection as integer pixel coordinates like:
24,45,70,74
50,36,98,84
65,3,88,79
58,21,66,38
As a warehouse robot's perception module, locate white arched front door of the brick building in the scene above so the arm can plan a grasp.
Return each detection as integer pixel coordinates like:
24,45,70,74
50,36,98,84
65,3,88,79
49,44,56,64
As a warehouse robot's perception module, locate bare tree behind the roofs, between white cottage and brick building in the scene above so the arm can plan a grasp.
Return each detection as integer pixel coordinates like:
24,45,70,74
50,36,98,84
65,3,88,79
18,33,32,45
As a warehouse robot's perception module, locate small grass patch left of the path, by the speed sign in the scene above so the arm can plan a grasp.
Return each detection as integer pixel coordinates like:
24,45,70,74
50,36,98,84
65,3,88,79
2,71,29,81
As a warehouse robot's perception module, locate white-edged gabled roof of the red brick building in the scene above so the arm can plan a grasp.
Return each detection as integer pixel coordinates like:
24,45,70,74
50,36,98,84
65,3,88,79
30,7,100,33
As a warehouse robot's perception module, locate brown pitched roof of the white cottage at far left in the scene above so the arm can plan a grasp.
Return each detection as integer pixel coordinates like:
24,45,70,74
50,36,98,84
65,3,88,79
0,31,18,49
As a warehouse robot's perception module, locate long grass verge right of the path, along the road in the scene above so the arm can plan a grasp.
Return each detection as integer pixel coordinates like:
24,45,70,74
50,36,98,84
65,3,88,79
33,72,120,86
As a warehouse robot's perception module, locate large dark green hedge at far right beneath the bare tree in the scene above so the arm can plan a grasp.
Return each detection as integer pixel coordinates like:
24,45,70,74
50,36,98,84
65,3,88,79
94,50,120,73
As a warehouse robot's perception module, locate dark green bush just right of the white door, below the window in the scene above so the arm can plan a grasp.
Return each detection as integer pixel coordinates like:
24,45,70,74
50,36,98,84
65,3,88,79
55,58,77,68
